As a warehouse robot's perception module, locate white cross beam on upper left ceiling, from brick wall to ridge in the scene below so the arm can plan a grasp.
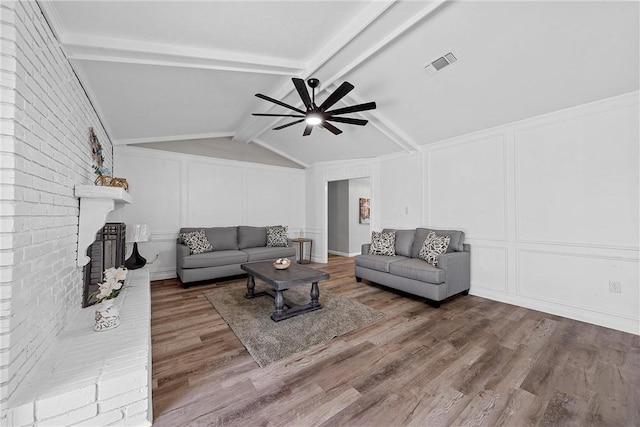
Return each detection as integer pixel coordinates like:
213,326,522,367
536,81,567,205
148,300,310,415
59,33,305,75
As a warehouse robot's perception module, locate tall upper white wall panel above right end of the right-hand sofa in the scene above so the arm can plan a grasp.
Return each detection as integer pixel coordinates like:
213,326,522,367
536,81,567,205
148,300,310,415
426,136,507,241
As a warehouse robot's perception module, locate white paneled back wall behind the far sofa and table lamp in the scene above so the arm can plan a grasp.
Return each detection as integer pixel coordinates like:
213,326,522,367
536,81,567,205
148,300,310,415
109,146,305,280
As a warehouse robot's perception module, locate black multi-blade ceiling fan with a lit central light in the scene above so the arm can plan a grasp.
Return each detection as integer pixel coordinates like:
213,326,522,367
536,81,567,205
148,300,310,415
252,77,376,136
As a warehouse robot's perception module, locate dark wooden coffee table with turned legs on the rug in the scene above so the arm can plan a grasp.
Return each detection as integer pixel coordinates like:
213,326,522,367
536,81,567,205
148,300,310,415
241,261,329,322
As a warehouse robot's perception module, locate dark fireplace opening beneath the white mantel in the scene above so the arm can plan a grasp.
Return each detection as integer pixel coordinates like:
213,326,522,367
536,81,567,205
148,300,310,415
82,222,127,307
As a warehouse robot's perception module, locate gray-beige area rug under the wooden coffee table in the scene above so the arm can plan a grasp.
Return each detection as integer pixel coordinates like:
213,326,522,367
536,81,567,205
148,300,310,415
204,280,383,367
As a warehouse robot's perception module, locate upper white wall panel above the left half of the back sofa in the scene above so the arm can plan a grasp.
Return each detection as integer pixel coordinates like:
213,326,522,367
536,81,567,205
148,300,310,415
185,162,243,227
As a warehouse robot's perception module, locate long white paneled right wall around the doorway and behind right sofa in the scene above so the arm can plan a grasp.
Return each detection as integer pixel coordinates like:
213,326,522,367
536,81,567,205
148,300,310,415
307,92,640,334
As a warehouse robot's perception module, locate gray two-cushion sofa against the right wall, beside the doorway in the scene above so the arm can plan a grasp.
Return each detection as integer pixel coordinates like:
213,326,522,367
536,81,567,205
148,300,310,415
355,228,471,307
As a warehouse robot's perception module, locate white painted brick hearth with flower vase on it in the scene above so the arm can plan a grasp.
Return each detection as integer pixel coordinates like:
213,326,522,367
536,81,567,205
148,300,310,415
8,268,153,427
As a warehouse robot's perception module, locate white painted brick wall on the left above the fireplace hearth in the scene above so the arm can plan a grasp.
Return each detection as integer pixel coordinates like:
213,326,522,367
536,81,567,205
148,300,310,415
0,0,119,425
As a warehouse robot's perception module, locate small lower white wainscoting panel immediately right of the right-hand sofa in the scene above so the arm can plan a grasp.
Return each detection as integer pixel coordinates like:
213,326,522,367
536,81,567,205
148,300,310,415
469,246,509,294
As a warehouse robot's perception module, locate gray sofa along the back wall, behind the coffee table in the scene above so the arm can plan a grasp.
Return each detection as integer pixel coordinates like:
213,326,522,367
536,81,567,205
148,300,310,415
176,226,296,288
